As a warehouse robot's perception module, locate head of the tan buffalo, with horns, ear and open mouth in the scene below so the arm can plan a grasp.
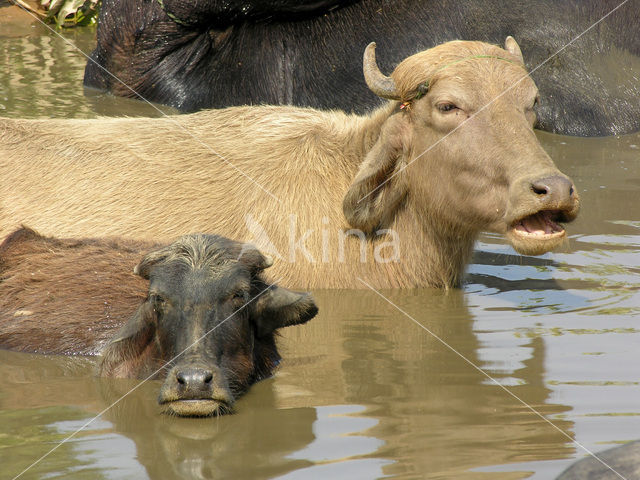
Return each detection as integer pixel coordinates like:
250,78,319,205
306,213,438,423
343,37,579,255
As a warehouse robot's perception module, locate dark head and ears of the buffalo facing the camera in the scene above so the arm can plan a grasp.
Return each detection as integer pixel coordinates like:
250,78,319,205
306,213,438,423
100,235,318,416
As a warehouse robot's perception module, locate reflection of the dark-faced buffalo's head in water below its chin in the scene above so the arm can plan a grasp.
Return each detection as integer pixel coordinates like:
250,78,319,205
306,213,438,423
101,380,316,479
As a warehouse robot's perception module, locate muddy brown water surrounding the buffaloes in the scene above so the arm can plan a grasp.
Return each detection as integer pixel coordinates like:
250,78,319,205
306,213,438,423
0,11,640,479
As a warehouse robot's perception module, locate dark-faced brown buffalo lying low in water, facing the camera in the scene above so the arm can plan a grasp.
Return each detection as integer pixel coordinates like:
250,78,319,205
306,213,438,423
0,228,318,416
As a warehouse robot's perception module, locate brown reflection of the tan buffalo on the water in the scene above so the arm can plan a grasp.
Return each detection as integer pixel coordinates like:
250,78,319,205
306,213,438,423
285,290,572,478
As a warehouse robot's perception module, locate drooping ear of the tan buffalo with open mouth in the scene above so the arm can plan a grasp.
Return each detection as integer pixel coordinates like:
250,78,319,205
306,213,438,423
342,113,409,233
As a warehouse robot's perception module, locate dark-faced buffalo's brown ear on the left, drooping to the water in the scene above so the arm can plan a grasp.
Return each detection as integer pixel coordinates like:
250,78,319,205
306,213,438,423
98,301,156,378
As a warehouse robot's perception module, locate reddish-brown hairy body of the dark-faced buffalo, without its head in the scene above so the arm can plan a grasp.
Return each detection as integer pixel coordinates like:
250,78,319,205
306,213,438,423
0,228,151,355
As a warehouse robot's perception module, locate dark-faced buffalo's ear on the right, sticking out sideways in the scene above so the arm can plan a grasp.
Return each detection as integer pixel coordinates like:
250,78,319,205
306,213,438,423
255,285,318,337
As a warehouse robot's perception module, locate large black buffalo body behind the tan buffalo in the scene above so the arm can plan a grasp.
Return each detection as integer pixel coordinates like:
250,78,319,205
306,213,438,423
84,0,640,136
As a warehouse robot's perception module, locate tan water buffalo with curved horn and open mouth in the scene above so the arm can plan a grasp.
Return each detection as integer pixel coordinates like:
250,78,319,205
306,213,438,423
0,37,579,288
